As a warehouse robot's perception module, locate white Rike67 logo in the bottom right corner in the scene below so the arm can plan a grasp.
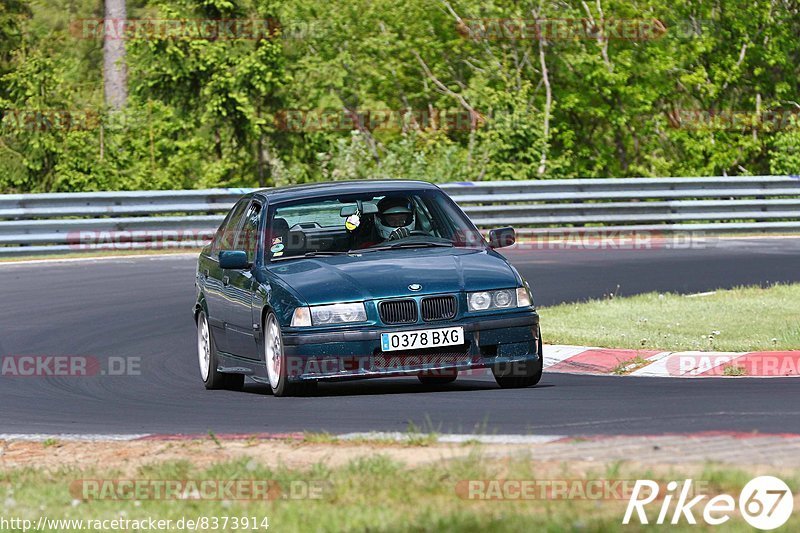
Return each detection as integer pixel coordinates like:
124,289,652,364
622,476,794,531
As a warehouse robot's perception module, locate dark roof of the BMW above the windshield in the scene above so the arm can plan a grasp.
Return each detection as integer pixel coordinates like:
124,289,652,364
253,180,438,203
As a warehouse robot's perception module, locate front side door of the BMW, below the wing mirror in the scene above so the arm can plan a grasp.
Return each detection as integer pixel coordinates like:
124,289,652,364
224,199,264,359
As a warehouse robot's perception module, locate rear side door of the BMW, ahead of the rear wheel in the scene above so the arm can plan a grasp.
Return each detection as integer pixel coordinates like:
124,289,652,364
200,199,249,352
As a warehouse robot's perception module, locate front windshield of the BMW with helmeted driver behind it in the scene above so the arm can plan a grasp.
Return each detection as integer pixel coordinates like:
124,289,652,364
266,189,485,261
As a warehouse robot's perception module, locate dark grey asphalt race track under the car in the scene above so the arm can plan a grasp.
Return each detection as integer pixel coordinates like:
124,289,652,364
0,239,800,435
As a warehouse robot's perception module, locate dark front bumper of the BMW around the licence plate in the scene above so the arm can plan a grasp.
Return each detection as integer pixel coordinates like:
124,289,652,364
283,309,541,381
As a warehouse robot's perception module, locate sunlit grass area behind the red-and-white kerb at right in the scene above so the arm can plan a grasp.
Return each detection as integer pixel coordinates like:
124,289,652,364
540,284,800,352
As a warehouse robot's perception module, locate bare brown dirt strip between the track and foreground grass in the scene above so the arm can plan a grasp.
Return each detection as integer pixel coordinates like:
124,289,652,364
0,435,800,474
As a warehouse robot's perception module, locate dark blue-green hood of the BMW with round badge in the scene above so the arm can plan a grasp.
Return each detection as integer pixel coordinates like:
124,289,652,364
268,248,519,304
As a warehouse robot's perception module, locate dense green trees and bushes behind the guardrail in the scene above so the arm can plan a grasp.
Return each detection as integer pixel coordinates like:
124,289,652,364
0,0,800,192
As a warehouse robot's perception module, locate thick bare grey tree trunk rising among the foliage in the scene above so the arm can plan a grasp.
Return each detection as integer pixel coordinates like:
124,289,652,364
103,0,128,111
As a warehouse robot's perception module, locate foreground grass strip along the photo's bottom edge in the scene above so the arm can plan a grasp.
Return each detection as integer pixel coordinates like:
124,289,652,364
0,449,800,532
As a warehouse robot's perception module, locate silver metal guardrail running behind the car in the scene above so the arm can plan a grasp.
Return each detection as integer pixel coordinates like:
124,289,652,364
0,176,800,256
